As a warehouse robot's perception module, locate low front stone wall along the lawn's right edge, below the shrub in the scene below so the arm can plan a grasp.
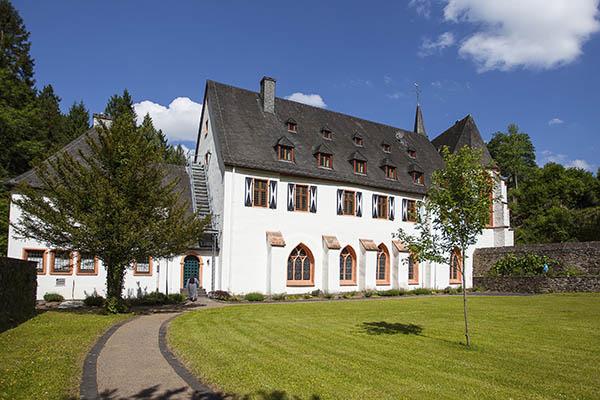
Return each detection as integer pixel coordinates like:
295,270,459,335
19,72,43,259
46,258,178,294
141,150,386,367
473,276,600,293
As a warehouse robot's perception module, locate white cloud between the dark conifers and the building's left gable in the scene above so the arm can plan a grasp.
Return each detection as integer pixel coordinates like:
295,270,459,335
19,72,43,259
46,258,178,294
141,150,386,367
133,97,202,141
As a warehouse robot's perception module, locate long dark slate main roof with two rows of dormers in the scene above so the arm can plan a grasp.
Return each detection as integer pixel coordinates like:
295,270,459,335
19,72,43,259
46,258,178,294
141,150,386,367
206,80,444,194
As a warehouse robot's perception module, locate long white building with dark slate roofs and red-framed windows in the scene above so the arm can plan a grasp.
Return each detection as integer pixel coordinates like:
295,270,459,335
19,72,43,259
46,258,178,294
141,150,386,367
8,77,513,298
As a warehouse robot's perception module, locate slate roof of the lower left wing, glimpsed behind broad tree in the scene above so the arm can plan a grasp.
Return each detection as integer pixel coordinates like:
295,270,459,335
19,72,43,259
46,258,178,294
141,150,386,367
8,128,194,216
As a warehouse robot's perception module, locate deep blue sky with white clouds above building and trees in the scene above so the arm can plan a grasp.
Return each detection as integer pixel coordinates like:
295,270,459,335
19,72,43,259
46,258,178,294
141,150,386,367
13,0,600,172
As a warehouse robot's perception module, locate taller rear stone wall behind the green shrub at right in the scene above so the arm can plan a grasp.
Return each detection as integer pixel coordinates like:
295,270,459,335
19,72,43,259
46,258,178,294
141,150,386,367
473,242,600,277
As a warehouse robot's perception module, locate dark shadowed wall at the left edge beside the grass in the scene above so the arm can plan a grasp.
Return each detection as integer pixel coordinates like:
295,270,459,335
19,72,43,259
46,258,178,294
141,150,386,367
0,257,37,332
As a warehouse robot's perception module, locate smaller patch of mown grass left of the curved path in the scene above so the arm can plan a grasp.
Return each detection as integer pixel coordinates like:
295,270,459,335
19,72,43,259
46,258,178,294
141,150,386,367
0,311,130,399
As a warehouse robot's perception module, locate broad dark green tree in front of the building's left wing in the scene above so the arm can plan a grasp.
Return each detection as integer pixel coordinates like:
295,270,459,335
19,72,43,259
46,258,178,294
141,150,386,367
13,113,208,311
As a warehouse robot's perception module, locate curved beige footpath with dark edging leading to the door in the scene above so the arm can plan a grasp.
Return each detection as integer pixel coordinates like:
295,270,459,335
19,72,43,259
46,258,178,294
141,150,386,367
80,299,223,400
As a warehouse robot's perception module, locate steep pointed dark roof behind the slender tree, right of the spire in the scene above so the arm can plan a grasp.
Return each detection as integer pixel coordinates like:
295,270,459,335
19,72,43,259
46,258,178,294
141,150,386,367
431,114,493,166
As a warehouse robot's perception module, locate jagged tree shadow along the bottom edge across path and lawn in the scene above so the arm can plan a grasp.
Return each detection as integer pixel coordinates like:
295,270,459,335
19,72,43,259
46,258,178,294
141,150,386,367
99,385,321,400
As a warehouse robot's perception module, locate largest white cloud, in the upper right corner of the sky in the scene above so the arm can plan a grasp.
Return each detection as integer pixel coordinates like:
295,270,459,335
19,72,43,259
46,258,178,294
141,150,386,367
444,0,600,72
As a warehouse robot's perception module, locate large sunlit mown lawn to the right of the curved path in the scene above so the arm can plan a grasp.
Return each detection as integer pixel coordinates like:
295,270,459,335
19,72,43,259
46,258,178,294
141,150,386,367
168,294,600,399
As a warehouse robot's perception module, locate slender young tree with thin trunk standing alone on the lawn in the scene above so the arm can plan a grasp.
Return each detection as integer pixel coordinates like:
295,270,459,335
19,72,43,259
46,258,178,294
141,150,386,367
395,147,496,346
